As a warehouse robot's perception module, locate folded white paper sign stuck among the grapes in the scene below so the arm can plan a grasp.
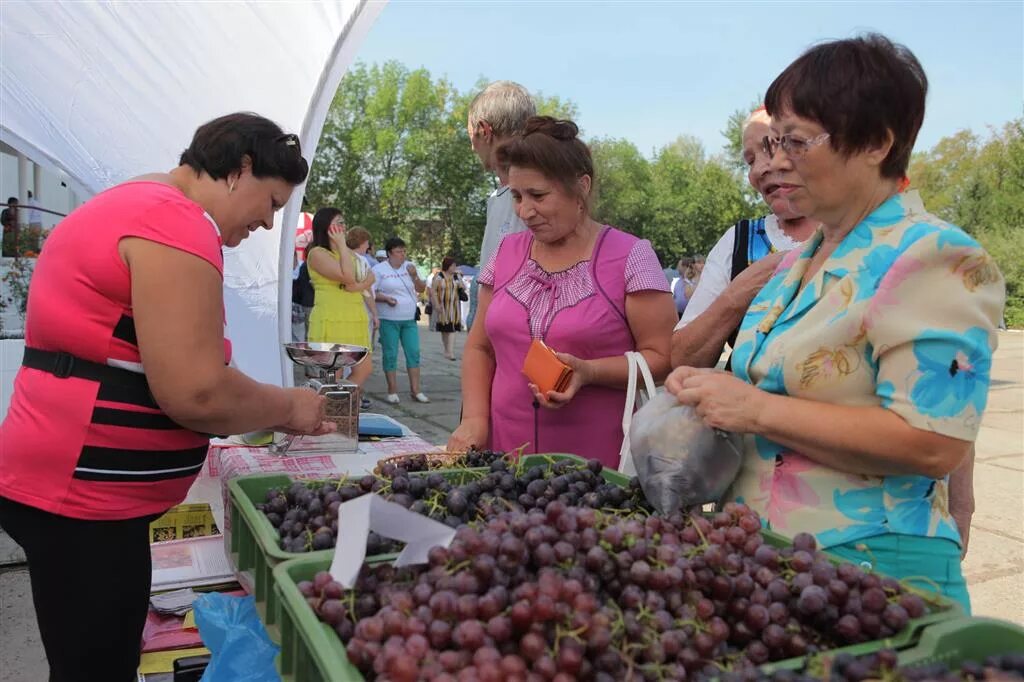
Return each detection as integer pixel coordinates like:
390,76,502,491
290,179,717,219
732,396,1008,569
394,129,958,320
331,495,455,588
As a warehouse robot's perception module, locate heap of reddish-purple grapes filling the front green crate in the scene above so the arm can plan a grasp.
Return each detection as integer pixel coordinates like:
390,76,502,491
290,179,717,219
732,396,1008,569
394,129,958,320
300,501,937,680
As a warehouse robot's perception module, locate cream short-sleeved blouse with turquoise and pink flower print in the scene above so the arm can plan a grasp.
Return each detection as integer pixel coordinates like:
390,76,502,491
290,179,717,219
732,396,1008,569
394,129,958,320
727,191,1006,547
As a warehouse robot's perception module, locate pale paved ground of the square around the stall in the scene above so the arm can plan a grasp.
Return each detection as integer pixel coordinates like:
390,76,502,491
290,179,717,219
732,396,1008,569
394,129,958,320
0,328,1024,682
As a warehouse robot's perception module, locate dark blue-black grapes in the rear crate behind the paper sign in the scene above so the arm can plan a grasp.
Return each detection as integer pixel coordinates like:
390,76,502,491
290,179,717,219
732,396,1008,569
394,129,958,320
257,458,645,556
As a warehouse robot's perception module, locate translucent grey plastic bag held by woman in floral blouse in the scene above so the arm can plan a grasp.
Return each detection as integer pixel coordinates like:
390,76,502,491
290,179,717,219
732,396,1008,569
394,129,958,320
630,393,742,514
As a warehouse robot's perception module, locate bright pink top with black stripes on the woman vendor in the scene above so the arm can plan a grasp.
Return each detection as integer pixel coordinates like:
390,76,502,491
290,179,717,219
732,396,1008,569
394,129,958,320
0,181,230,520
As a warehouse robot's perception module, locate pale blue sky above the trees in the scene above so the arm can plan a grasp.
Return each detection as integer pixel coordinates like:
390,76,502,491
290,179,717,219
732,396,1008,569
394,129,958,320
356,0,1024,155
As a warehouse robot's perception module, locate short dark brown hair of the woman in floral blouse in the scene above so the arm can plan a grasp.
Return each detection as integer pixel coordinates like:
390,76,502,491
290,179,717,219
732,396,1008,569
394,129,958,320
765,33,928,178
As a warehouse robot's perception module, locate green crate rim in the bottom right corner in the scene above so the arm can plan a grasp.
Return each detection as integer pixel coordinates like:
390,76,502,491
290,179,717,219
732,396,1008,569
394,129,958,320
899,619,1024,667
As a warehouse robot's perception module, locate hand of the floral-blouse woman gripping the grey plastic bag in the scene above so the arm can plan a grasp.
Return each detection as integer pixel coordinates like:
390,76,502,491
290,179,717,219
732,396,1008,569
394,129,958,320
665,367,770,433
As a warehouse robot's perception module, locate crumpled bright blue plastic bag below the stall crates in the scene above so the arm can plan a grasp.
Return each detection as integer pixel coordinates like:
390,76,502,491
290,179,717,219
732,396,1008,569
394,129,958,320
193,592,281,682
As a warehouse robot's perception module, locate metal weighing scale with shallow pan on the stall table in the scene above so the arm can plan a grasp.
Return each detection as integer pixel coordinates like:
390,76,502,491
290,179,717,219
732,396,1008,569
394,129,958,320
270,343,369,456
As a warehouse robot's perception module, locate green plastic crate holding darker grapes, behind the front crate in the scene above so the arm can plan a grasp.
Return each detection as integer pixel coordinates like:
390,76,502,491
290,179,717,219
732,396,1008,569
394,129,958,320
231,454,630,642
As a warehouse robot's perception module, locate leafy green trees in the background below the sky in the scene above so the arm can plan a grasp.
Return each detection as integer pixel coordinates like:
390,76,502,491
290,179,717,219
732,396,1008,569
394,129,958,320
306,61,1024,326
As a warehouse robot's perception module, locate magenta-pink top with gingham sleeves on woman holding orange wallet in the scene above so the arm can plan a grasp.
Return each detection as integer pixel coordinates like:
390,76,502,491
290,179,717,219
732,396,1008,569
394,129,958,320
480,226,669,467
